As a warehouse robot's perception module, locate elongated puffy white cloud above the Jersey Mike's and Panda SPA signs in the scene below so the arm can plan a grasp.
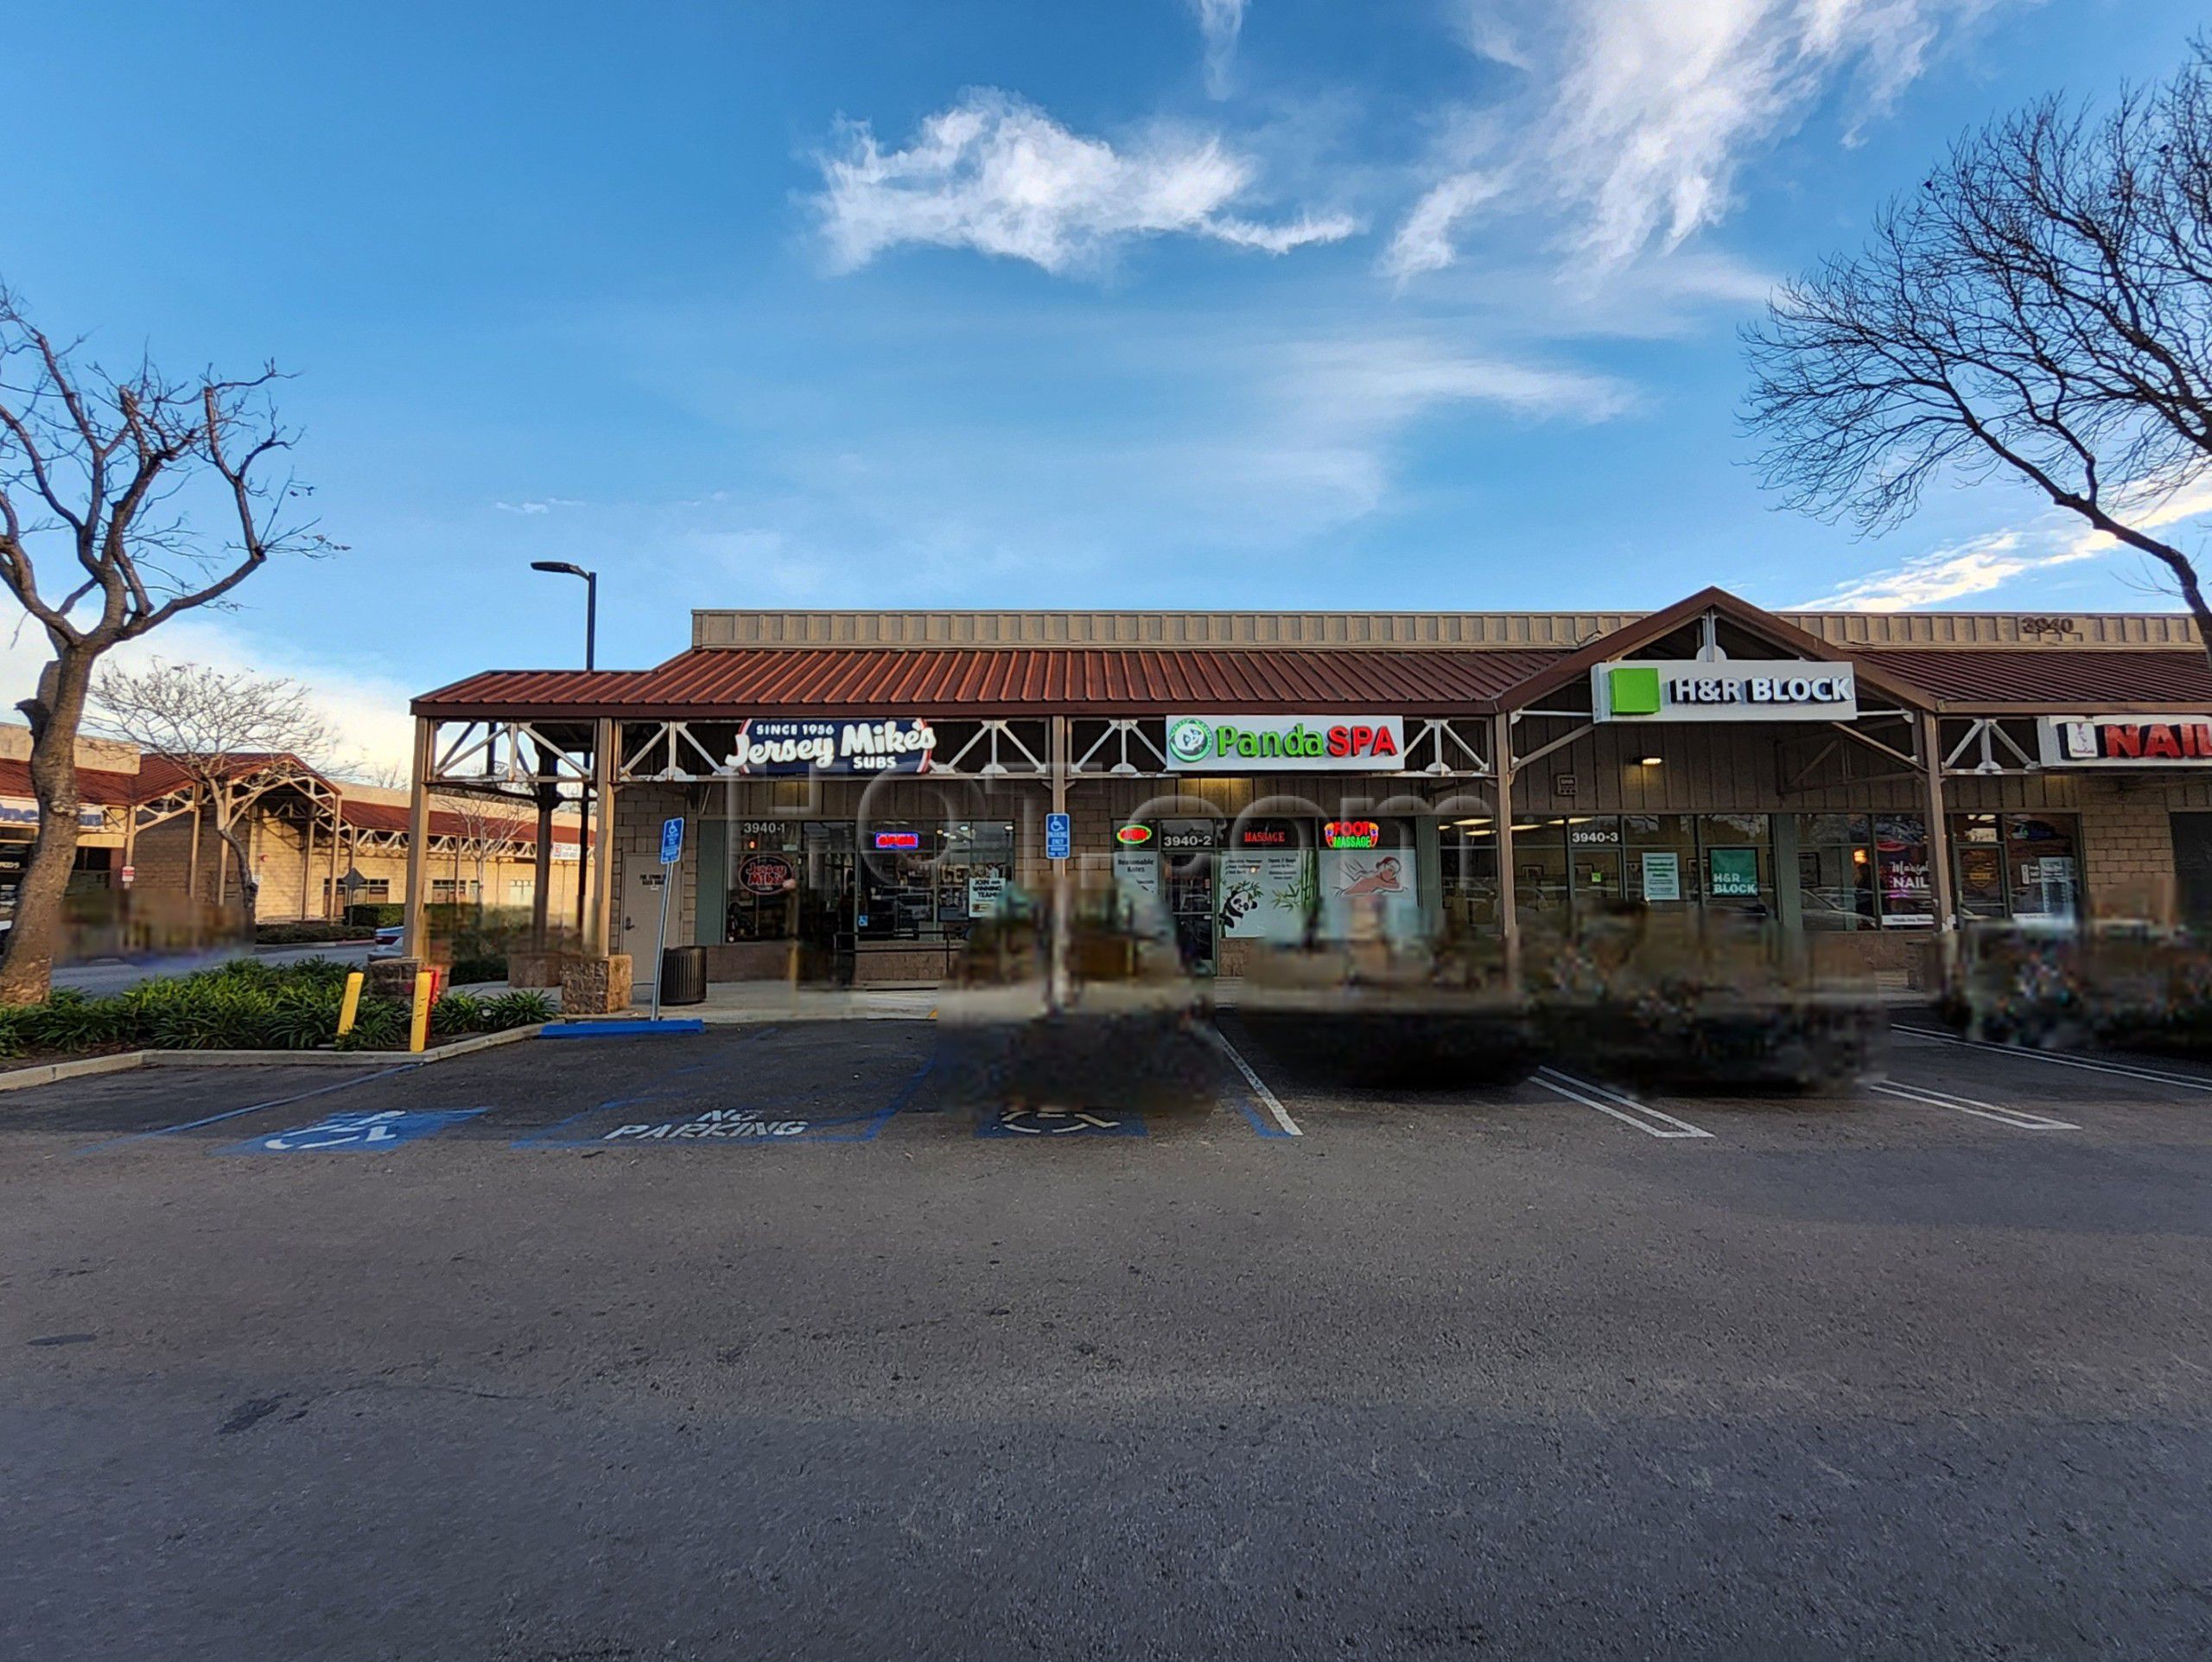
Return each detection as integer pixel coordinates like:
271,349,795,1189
814,91,1358,272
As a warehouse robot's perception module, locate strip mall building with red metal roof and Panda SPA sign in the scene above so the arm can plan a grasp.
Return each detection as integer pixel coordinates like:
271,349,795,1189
414,589,2212,1000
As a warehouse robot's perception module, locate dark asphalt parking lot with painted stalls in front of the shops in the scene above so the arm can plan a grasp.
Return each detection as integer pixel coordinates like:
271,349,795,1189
0,1014,2212,1662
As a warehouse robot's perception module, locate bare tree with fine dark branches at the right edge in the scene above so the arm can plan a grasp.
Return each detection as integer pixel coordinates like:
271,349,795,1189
1745,40,2212,657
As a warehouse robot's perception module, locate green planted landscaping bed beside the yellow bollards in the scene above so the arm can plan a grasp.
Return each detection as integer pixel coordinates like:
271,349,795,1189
0,958,553,1065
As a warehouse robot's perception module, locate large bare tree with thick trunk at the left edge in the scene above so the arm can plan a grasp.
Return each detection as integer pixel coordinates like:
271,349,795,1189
0,288,336,1005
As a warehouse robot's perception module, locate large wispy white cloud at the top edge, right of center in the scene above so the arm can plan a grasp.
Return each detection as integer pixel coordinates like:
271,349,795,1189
1387,0,1991,275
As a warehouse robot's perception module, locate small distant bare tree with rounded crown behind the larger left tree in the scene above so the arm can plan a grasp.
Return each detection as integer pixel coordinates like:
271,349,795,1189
91,657,332,927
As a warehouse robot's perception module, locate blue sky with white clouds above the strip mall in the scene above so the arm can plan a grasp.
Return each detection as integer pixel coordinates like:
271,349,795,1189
0,0,2201,755
